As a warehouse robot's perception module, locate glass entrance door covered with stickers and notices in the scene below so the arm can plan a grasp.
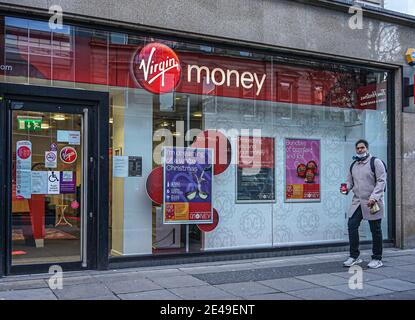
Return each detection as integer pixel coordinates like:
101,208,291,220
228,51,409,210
9,108,87,267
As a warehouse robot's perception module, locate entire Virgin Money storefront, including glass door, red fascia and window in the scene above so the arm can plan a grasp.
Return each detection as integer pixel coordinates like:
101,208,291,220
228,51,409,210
0,16,394,274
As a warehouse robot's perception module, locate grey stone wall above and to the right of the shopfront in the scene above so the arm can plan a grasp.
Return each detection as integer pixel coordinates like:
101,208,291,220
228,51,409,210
0,0,415,247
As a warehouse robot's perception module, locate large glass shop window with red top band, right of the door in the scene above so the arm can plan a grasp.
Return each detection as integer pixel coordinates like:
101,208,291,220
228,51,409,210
0,18,389,256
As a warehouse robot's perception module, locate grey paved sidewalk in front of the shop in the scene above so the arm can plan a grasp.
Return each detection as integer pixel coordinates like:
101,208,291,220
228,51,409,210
0,249,415,300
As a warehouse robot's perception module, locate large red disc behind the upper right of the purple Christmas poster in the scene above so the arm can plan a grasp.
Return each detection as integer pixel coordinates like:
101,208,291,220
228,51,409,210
192,130,232,175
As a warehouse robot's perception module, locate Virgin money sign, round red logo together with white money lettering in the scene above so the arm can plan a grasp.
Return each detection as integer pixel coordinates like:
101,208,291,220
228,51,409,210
132,42,267,99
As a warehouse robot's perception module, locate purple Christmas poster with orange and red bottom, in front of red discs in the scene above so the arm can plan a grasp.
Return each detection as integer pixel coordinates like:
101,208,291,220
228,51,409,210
163,147,214,224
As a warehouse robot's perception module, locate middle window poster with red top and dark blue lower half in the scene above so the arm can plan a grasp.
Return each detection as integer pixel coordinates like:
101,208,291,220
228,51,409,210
236,136,275,203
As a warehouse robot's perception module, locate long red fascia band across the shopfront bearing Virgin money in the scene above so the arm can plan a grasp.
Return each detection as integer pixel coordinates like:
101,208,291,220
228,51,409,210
4,27,381,109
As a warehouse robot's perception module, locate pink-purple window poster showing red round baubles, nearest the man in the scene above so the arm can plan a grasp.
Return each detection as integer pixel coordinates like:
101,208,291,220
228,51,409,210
284,138,321,202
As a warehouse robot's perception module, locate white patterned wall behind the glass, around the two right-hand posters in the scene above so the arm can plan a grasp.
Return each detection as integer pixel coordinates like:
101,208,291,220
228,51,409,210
204,99,386,250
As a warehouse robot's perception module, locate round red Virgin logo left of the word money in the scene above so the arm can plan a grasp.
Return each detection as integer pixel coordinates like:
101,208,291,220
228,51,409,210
132,42,181,94
